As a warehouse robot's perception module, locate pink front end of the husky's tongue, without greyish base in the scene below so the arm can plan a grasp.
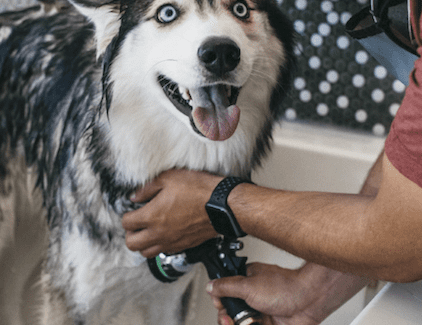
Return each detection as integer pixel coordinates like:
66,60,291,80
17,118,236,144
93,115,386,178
192,105,240,141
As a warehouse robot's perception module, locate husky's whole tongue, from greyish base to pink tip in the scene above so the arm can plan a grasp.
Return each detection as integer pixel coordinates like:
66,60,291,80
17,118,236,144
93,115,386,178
189,85,240,141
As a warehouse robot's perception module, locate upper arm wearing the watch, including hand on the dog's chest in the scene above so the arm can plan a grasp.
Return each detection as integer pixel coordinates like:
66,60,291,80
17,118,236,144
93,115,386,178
123,148,422,282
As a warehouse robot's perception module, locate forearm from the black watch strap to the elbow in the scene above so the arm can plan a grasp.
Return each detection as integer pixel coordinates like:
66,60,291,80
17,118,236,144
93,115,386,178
229,184,371,272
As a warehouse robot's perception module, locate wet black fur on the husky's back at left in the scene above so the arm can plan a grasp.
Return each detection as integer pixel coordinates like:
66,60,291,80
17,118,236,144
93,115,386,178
0,7,97,199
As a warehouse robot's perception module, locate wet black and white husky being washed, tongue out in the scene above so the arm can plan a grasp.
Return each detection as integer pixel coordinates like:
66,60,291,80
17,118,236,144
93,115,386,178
0,0,294,325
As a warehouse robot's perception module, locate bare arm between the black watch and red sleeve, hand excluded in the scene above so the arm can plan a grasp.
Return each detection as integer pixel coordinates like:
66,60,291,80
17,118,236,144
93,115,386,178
229,151,421,281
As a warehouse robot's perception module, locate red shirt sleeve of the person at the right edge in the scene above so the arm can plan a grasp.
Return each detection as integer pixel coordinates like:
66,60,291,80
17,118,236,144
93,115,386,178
385,1,422,187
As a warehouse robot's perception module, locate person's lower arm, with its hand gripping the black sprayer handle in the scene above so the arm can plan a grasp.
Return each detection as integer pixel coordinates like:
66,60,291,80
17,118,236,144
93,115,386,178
207,152,383,325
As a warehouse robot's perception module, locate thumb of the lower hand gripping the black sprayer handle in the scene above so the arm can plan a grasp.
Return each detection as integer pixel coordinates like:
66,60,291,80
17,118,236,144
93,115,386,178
206,276,249,300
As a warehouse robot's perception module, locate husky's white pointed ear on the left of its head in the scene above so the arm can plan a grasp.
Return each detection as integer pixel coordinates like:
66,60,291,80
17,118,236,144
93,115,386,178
69,0,121,58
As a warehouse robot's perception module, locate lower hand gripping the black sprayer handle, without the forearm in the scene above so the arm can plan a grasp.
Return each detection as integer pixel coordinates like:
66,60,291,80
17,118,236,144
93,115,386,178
207,263,324,325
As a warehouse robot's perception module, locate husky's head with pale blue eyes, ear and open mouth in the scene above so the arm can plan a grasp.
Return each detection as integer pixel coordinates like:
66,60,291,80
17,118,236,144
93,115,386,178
71,0,292,140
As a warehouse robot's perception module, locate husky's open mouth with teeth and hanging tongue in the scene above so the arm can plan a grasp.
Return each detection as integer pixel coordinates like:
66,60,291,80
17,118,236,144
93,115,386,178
158,75,240,141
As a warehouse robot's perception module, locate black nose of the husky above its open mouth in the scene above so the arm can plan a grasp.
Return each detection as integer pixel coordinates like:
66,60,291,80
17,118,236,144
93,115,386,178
198,37,240,77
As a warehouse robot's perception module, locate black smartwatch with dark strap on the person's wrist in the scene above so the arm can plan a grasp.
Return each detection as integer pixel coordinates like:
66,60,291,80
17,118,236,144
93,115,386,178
205,176,253,238
